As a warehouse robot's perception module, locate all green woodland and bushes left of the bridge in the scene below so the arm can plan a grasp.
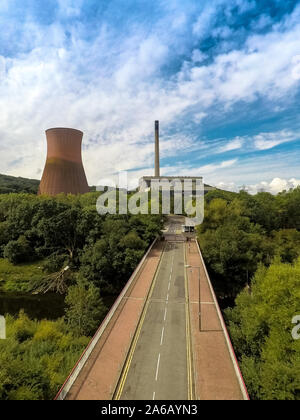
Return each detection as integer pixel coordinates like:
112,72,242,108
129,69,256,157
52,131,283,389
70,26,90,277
0,193,163,400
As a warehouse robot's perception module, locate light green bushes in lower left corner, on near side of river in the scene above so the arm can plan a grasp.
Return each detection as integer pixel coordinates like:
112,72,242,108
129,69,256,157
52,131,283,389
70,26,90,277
0,312,89,400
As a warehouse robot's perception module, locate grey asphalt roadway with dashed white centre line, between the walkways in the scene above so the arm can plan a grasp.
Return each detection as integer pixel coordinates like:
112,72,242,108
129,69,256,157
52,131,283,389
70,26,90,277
119,243,191,400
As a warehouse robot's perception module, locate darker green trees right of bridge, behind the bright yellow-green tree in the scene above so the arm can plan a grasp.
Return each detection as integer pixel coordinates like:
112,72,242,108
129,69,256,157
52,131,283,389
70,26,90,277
198,187,300,303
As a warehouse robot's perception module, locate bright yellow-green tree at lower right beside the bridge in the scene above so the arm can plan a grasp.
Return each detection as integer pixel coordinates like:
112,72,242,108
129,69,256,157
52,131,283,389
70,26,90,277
226,259,300,400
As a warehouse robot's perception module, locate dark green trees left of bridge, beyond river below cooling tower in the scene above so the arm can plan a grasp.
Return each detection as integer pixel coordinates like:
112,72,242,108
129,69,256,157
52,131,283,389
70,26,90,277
0,193,162,294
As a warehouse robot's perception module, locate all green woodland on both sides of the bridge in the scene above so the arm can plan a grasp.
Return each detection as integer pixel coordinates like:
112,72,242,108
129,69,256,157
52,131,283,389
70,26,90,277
0,183,300,400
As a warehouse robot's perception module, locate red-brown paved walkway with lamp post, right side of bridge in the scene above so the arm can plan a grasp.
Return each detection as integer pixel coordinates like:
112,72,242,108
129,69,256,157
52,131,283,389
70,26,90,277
186,242,247,400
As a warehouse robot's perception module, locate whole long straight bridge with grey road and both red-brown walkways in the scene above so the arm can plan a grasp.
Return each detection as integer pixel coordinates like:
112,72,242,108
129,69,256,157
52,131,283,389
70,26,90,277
57,218,249,400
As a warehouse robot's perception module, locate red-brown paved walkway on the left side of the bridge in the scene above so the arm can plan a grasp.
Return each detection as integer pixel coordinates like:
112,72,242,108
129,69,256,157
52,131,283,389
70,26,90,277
66,243,163,400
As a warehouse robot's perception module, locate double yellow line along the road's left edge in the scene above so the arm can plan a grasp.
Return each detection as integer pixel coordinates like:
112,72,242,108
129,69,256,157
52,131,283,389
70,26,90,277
113,246,166,400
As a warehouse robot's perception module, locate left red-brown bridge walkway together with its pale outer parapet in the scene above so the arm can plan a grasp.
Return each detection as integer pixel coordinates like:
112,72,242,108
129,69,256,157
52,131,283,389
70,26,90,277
55,239,163,400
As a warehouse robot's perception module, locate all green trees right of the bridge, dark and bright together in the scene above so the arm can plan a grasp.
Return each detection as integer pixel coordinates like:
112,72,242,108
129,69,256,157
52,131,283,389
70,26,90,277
198,188,300,400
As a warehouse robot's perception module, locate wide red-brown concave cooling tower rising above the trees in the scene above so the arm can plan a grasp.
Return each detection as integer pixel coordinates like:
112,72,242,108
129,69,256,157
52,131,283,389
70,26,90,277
38,128,89,196
